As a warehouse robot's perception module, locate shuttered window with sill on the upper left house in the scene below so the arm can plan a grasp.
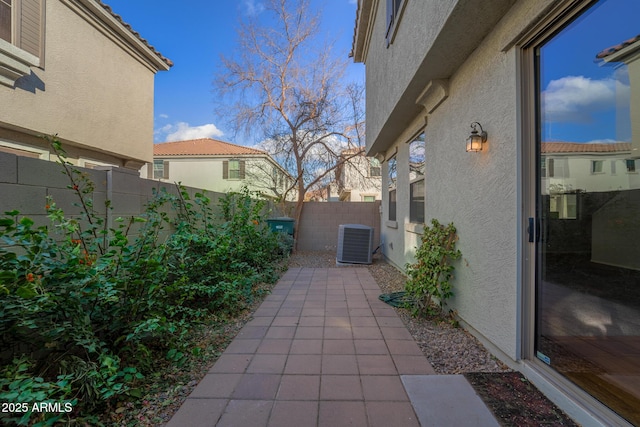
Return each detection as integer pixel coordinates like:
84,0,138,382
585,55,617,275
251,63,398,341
0,0,44,87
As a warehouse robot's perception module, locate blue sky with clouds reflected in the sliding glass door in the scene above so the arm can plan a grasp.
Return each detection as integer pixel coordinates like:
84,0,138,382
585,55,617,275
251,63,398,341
540,0,640,143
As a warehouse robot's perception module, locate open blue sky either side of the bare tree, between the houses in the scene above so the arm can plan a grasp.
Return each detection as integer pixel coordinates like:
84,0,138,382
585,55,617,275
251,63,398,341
103,0,364,145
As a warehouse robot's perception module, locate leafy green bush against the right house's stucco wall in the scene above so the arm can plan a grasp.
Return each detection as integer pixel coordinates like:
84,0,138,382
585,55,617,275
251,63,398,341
405,219,461,316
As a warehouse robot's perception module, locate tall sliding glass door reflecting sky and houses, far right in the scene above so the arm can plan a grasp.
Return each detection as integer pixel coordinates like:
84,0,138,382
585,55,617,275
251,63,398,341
531,0,640,425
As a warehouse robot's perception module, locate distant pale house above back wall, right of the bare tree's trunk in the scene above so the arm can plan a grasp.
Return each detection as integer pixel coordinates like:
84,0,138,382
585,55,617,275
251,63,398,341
329,147,382,202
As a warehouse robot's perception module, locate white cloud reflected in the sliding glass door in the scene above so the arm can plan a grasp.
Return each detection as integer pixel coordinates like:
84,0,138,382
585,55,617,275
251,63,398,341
542,76,631,123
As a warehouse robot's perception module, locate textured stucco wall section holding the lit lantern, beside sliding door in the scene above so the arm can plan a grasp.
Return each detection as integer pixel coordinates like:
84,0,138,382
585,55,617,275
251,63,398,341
425,39,519,359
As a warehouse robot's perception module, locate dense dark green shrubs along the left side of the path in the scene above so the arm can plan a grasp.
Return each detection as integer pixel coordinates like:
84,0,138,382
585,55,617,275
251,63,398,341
0,138,288,425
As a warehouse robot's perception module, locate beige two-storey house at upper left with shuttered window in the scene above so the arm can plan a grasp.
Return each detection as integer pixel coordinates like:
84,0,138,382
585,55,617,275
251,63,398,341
0,0,172,170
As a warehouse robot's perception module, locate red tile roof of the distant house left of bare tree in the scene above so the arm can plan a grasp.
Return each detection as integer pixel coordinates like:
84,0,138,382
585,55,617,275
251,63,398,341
153,138,266,156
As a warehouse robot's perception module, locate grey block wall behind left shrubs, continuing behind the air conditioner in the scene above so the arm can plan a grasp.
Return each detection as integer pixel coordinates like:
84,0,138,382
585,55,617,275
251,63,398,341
0,152,380,251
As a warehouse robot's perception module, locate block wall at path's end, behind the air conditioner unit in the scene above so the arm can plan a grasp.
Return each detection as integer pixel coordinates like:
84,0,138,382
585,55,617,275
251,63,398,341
296,200,380,251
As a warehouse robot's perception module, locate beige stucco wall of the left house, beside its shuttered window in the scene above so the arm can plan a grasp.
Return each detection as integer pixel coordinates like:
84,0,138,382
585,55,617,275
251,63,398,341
0,1,161,167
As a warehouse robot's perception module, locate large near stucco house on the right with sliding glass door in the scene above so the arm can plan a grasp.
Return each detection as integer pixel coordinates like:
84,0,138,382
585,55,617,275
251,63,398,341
352,0,640,425
